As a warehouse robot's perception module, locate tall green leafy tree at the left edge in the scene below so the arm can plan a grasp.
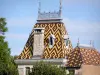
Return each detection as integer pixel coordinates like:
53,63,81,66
0,18,18,75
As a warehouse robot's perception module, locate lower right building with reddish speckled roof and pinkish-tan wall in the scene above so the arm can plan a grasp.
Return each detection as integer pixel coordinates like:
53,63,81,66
66,44,100,75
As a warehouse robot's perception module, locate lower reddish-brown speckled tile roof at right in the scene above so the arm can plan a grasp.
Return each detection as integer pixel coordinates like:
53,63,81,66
66,46,100,67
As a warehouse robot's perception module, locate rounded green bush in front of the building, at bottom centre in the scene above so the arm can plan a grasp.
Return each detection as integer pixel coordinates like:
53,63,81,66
29,62,66,75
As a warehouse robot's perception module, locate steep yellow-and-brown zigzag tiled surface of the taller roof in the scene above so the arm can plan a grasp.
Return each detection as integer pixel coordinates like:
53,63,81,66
18,22,72,59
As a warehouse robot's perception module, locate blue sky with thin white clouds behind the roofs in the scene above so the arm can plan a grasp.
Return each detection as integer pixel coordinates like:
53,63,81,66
0,0,100,55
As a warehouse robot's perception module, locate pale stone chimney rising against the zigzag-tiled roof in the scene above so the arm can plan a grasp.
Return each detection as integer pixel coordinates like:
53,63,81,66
33,28,44,58
